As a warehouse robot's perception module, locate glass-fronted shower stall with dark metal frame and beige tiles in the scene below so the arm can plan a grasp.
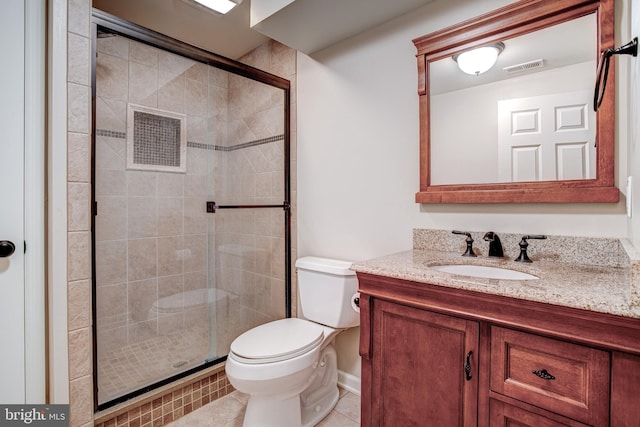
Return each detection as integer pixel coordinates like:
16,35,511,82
92,11,291,409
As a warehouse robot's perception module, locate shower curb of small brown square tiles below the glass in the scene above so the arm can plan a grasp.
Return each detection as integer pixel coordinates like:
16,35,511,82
94,365,234,427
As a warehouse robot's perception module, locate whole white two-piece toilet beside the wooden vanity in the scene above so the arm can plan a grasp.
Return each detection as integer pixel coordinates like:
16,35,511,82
225,257,360,427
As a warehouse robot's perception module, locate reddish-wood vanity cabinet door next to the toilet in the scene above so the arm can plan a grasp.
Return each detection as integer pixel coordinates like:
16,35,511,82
370,300,479,427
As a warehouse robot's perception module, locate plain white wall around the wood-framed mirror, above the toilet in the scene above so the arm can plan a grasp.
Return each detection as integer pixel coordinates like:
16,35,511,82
297,0,640,382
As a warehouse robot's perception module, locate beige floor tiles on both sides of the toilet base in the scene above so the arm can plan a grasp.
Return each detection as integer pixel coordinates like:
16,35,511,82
167,389,360,427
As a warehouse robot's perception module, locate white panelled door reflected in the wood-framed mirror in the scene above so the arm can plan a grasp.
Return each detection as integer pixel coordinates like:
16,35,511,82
498,92,596,182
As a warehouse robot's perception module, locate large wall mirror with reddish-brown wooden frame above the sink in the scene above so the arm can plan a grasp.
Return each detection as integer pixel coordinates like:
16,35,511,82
414,0,619,203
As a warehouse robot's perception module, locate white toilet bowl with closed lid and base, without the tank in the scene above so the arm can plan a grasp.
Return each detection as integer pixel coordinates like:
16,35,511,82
226,318,339,427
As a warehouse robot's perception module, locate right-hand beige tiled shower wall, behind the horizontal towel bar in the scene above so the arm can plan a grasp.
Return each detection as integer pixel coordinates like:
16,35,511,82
215,47,295,353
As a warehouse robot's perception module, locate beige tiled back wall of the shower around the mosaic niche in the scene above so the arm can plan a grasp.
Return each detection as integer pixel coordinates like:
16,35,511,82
95,36,222,403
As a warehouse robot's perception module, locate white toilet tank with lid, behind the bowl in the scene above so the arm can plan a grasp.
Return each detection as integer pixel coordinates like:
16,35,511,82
296,257,360,328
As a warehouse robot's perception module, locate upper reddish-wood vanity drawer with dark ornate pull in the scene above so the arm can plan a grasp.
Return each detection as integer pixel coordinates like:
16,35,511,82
490,326,610,425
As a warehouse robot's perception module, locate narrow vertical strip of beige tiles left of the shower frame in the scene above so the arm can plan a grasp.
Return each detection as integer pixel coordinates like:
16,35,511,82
67,0,93,427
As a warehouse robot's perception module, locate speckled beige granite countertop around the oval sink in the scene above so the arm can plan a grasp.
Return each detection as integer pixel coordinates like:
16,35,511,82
351,231,640,318
